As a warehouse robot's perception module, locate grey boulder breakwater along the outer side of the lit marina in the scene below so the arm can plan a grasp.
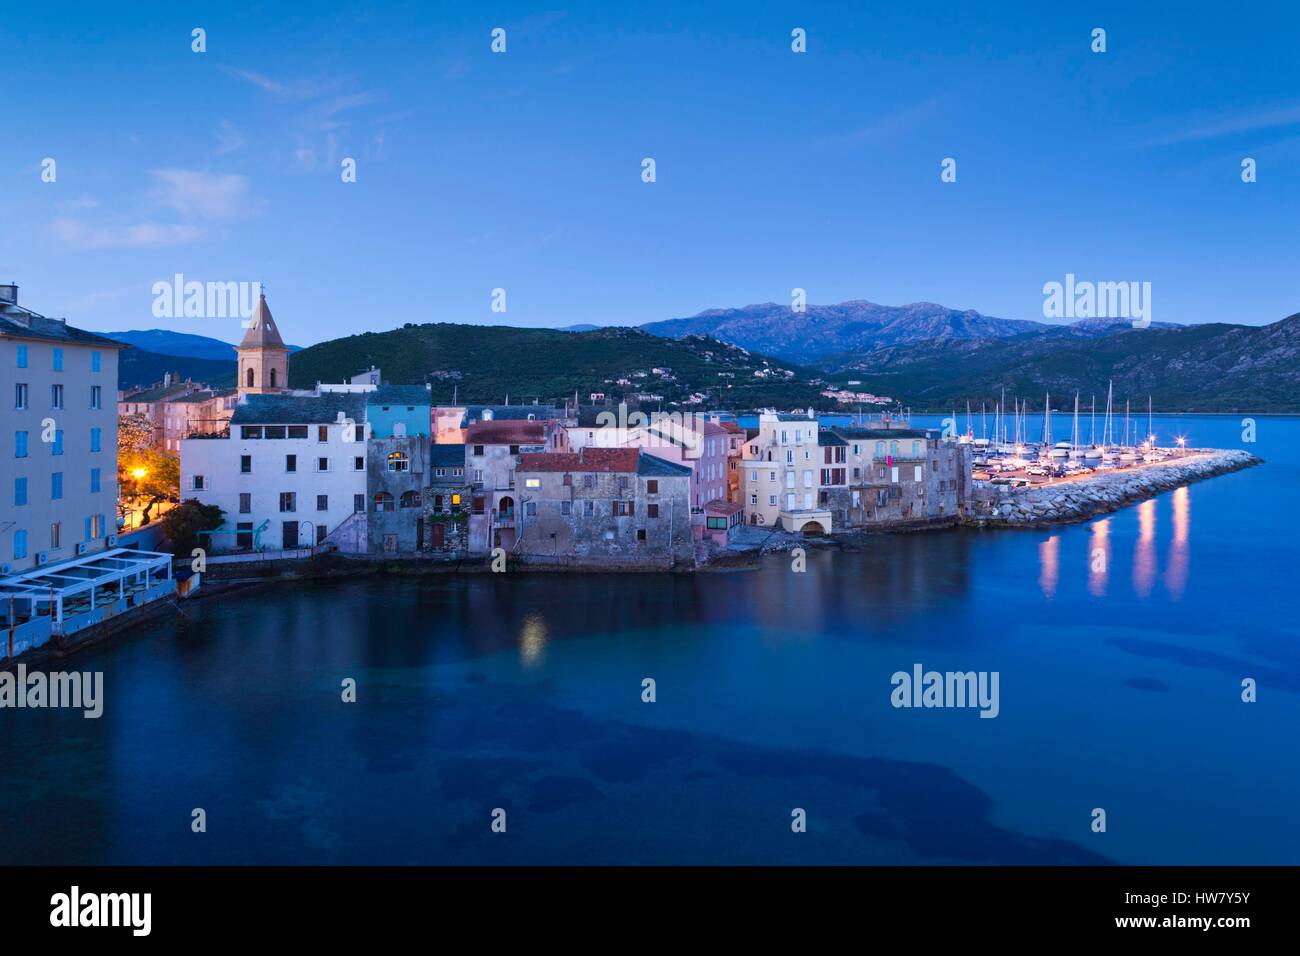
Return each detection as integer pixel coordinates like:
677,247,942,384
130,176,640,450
961,449,1264,528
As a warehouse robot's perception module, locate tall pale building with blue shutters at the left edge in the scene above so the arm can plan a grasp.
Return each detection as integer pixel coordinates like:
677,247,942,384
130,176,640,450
0,285,125,575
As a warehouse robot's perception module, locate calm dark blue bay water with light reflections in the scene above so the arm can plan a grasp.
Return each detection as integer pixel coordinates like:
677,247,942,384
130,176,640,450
0,415,1300,864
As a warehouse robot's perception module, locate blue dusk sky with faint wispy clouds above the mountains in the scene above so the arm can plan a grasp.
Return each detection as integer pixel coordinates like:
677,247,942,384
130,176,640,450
0,0,1300,346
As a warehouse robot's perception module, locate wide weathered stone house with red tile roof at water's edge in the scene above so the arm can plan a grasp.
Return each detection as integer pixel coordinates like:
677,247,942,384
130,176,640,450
517,447,694,567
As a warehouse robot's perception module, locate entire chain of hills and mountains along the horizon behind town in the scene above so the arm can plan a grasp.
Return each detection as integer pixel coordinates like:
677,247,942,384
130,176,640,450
111,300,1300,412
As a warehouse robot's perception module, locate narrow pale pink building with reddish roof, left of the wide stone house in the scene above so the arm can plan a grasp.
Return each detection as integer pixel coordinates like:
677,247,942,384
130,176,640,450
465,418,568,554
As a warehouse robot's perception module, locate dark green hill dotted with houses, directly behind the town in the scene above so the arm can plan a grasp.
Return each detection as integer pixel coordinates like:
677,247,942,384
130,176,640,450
289,323,829,408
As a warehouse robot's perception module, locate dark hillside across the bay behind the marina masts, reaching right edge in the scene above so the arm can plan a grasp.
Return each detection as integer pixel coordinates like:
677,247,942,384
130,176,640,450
826,313,1300,411
